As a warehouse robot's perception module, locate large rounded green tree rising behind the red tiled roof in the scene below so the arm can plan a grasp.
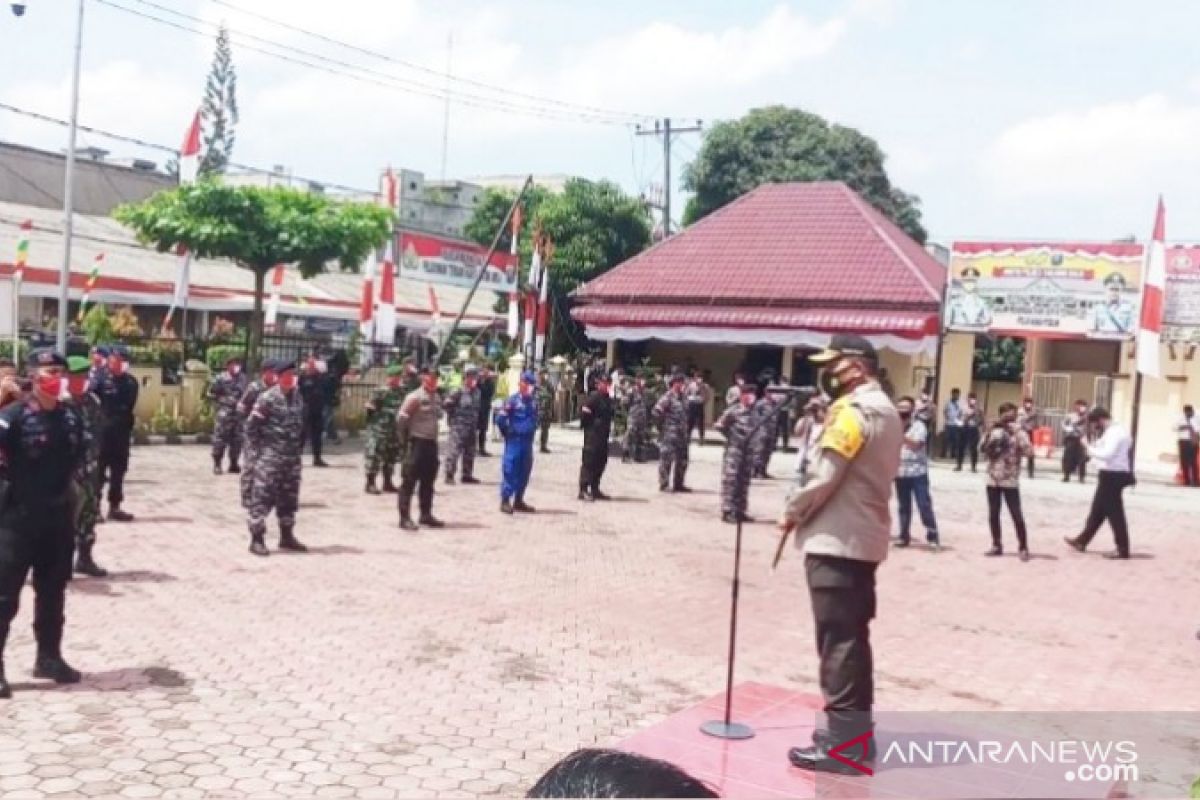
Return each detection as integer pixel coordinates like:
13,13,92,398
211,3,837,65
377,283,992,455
683,106,926,243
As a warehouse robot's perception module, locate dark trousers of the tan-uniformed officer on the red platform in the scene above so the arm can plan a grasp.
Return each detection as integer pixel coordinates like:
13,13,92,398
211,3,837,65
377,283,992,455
804,555,877,740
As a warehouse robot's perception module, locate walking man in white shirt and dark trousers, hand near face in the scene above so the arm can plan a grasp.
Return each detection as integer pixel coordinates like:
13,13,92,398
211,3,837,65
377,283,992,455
1066,408,1136,559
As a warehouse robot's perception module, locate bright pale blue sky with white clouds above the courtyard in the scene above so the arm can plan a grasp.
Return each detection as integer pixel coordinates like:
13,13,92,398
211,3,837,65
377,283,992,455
0,0,1200,242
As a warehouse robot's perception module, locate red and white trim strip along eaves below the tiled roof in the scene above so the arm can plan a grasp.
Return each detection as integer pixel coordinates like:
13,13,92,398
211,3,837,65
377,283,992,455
574,303,937,337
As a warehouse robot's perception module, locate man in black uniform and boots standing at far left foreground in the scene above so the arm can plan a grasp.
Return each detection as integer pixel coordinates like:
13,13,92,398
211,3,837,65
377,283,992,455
0,349,88,698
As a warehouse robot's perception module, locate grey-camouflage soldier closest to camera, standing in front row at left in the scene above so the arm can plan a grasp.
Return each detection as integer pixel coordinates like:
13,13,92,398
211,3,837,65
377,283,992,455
246,363,308,555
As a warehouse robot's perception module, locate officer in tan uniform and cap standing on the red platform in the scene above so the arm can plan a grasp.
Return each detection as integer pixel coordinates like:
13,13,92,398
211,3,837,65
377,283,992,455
776,335,904,775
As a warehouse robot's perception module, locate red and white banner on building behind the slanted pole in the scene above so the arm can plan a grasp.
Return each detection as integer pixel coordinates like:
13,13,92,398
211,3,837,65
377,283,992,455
396,230,517,294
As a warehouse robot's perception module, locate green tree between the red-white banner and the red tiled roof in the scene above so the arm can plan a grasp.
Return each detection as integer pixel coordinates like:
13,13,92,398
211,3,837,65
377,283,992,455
466,178,650,357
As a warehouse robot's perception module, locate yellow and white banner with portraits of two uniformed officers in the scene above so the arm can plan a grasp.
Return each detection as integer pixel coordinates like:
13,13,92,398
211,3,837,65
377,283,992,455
943,242,1144,341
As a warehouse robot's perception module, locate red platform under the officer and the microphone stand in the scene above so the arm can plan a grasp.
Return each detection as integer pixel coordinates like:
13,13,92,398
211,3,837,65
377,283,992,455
618,682,1124,800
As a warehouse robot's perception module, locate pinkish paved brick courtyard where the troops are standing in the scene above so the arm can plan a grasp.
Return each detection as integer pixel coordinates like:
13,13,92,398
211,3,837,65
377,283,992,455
0,429,1200,800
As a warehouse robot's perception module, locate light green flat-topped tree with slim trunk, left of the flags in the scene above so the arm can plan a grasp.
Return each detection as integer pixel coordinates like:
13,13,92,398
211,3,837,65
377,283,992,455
113,181,392,365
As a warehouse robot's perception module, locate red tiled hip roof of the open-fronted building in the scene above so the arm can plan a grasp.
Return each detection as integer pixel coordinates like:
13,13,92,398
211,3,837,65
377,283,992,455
575,182,946,313
